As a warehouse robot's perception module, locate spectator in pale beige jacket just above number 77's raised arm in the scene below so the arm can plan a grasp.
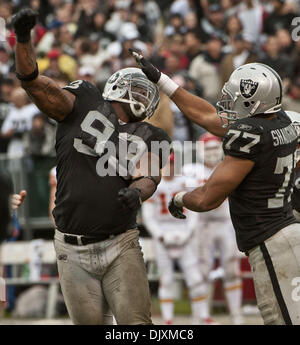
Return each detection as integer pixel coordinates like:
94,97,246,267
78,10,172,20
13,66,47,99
189,36,224,103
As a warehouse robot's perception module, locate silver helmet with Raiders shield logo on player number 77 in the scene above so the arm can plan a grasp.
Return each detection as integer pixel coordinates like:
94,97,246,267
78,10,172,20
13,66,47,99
217,63,282,127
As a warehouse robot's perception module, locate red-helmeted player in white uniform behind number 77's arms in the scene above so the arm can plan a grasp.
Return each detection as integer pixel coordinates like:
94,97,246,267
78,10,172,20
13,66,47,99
183,132,243,324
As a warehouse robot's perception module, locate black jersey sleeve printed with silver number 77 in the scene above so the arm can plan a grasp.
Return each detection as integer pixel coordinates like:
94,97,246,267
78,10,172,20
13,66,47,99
223,119,263,163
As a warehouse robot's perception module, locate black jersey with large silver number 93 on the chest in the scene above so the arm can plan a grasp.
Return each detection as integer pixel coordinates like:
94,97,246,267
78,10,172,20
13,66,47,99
53,80,170,236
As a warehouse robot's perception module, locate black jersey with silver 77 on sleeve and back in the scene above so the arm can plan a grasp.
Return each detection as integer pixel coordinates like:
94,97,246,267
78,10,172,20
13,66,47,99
223,111,297,251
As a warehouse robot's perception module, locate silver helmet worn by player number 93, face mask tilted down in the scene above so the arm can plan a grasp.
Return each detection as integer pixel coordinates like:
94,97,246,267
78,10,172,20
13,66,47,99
102,68,159,118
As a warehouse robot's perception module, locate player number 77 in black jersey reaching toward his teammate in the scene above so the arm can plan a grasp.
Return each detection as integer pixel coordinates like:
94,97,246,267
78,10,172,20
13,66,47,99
132,51,300,324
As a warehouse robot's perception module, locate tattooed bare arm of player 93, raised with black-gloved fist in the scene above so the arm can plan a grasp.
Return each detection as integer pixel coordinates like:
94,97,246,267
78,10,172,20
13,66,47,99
12,9,75,121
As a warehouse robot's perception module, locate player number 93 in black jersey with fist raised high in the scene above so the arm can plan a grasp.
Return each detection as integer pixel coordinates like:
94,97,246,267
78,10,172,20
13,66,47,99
13,9,170,324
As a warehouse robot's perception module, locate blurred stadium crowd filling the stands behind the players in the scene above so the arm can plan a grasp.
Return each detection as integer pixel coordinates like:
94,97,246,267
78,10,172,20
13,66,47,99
0,0,300,156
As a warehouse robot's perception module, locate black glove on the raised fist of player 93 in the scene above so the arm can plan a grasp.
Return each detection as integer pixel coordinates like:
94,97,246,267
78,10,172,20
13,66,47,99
12,8,38,43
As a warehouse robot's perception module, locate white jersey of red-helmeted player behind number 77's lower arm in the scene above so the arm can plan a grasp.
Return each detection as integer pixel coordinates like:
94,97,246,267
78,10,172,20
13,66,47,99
183,163,231,222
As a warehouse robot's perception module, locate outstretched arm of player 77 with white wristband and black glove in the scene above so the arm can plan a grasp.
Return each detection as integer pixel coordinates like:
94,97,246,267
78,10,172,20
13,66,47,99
130,49,227,137
